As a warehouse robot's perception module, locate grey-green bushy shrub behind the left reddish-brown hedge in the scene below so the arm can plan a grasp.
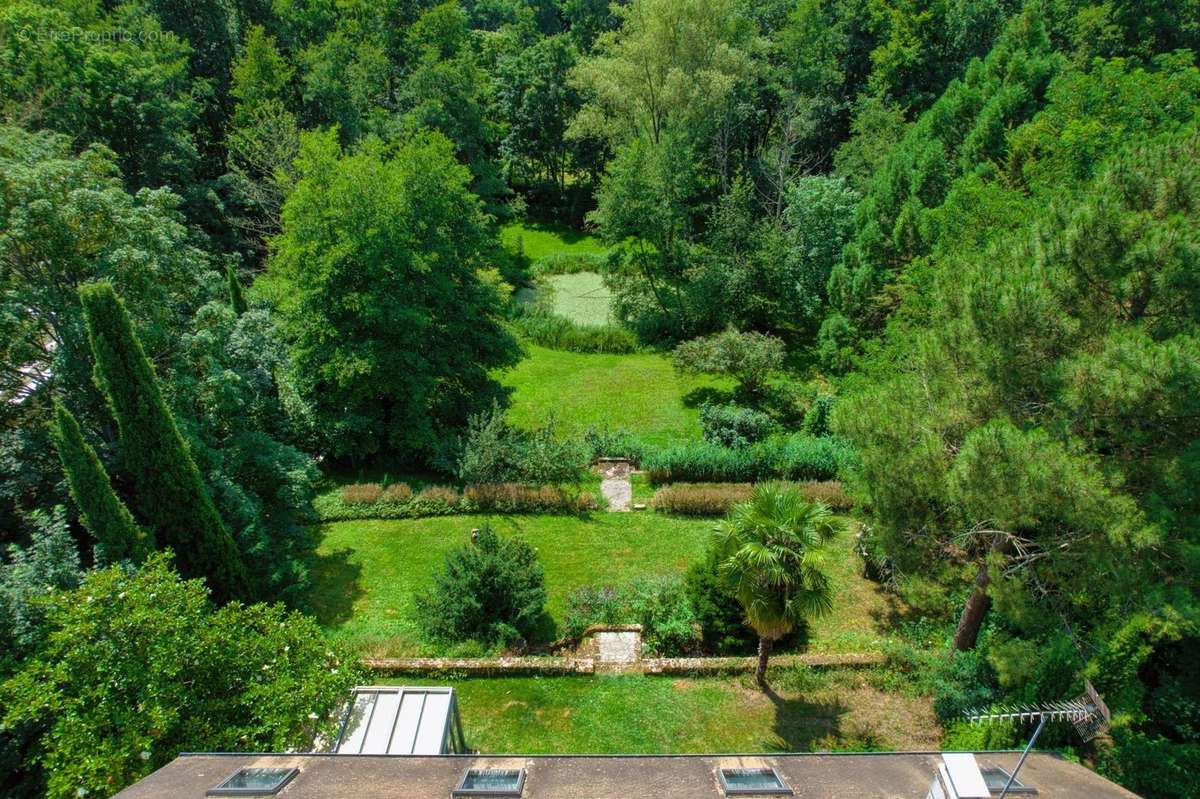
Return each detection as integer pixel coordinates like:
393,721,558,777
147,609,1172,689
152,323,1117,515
458,405,589,483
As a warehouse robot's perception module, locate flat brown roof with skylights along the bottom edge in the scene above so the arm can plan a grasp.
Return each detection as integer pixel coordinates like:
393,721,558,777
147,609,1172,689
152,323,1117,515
116,752,1136,799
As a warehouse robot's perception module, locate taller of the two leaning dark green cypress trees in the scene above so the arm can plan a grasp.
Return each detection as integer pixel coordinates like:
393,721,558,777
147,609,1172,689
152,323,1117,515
79,283,250,601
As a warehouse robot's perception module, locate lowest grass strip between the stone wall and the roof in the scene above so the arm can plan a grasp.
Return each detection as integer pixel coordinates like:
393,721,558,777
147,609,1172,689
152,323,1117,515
392,669,941,753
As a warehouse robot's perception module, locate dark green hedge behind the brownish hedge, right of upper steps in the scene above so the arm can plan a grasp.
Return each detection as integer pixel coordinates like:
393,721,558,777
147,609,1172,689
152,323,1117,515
642,434,854,485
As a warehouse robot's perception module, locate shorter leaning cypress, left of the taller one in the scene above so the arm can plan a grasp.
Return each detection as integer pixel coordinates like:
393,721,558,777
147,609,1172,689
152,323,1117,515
50,402,154,563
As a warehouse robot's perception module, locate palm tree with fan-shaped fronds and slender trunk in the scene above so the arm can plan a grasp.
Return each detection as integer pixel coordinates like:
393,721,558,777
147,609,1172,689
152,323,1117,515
716,483,840,691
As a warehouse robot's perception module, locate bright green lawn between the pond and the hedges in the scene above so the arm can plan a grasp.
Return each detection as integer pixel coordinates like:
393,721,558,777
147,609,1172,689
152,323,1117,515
499,344,733,445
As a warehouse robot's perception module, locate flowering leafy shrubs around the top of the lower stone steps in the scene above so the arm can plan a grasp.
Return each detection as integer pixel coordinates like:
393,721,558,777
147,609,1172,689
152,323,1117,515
563,576,700,657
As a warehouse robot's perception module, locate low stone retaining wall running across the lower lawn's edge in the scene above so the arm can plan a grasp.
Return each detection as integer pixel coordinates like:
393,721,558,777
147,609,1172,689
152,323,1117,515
362,653,883,677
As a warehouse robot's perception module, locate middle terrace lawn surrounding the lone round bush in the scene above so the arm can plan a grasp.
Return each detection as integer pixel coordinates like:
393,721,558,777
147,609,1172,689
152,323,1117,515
311,511,713,656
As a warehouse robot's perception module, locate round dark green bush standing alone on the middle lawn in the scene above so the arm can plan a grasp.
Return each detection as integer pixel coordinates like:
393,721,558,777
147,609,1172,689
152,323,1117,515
416,527,546,644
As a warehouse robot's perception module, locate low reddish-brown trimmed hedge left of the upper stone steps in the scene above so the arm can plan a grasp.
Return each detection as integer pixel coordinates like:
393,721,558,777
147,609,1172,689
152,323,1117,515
313,482,596,522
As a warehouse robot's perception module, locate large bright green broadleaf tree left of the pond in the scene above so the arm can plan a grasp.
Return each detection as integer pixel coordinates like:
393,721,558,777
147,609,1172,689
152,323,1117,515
265,127,517,458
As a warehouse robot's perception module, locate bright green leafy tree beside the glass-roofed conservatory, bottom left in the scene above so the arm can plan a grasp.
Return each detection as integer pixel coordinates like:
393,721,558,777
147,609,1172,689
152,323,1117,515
0,555,359,799
